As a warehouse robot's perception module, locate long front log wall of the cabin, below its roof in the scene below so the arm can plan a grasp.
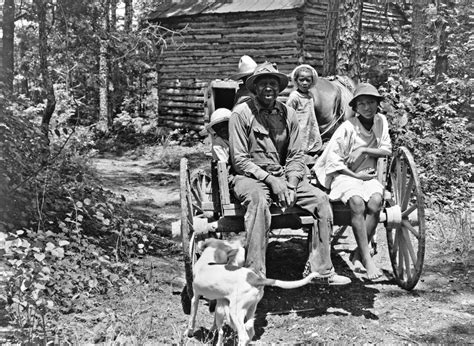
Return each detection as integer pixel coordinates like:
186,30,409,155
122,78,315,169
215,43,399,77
157,9,312,129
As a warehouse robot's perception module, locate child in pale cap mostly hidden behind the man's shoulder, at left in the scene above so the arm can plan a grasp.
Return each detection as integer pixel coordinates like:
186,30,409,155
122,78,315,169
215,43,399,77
204,108,232,162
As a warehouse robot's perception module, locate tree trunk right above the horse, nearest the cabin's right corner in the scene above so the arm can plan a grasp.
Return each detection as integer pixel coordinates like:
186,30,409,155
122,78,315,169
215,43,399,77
323,0,340,76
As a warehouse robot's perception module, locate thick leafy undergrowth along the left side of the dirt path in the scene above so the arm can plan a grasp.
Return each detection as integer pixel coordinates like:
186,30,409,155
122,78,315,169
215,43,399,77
0,109,169,342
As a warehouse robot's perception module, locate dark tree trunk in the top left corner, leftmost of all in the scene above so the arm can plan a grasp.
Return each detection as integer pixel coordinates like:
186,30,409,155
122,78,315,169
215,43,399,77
1,0,15,94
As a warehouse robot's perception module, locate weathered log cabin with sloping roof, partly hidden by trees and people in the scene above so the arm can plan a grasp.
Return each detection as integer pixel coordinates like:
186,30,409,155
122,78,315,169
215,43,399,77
149,0,412,131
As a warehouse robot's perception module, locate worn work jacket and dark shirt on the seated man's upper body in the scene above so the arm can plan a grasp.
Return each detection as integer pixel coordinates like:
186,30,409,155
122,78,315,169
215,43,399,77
229,98,306,181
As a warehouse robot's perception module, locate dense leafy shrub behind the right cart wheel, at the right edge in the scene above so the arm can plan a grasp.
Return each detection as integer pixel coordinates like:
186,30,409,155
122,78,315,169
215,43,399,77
382,77,473,209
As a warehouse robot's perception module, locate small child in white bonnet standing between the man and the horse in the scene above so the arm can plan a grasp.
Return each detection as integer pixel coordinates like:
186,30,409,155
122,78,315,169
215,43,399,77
286,64,322,163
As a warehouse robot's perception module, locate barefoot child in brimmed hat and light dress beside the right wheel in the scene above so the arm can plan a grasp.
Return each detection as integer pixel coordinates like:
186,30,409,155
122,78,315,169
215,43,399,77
313,83,392,280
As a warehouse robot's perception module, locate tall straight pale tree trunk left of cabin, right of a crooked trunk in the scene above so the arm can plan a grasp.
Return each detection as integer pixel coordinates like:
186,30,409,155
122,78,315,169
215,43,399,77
98,0,111,132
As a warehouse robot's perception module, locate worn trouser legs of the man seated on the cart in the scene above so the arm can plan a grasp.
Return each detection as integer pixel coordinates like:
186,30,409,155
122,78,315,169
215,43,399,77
231,175,333,274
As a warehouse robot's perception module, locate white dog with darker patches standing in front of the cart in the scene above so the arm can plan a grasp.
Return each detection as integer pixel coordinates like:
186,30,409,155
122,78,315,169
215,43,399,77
186,238,317,345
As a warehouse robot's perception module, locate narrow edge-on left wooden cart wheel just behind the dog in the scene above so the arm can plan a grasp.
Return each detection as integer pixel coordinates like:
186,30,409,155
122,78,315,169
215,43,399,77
179,158,198,314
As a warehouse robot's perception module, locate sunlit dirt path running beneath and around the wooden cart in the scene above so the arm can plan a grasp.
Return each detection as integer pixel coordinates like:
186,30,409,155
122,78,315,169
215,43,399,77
90,153,474,344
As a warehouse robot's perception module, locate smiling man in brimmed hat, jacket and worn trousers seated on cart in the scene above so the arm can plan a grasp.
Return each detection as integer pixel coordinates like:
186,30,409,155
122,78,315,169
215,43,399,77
229,62,351,285
